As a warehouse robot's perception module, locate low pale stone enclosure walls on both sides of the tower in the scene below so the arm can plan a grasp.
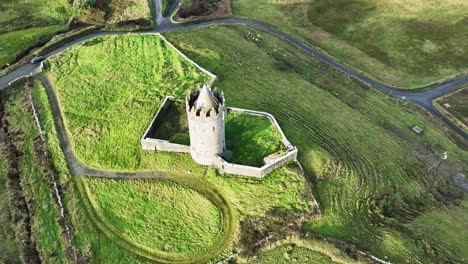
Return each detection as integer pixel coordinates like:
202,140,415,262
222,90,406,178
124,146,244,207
141,96,297,178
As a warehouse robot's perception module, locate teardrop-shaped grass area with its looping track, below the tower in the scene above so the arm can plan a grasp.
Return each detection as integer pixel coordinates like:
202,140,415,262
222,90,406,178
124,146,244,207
79,175,236,263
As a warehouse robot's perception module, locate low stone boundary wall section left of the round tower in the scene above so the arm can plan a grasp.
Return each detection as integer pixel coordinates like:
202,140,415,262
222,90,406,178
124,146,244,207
141,96,190,153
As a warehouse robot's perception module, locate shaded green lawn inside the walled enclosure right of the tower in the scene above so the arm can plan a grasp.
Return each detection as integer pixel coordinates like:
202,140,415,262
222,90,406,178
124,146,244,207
226,112,284,167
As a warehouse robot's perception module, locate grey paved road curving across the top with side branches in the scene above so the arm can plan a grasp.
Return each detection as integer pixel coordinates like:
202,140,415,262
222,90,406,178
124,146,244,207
0,0,468,140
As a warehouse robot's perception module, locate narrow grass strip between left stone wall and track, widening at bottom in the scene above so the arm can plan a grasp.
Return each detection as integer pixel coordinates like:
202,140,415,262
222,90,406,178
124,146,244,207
32,81,155,264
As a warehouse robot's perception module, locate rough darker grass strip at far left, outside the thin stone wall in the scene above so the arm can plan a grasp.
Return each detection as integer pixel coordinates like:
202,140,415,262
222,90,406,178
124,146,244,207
5,83,66,263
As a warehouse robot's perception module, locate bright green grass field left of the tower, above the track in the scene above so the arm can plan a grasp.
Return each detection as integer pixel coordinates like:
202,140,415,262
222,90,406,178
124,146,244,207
48,35,207,171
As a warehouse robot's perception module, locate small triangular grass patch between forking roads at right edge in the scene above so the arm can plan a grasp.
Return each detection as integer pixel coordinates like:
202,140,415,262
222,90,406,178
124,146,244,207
434,88,468,133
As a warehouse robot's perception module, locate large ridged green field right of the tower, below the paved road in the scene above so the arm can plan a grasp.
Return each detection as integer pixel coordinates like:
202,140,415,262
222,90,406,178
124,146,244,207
167,27,468,262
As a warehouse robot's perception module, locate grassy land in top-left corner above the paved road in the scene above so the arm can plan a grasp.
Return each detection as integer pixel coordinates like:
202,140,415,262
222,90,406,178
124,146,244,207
0,0,151,68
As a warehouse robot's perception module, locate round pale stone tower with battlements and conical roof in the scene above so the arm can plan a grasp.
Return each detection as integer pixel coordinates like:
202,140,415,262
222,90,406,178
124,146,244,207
186,85,227,165
